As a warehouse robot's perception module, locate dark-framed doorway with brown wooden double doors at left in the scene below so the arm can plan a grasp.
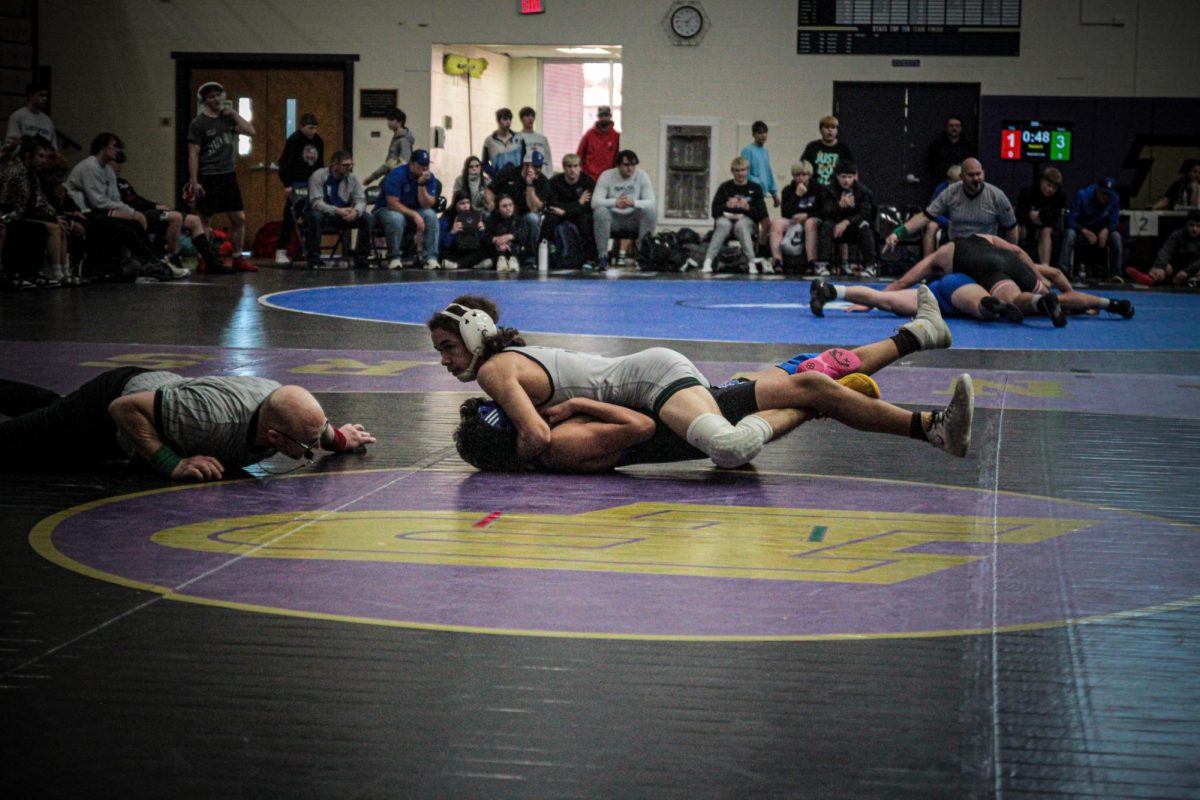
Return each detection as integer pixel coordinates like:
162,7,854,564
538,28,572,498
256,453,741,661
175,54,358,248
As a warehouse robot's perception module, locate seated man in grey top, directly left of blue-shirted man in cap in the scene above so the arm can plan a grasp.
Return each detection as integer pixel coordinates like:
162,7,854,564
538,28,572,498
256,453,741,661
304,150,373,269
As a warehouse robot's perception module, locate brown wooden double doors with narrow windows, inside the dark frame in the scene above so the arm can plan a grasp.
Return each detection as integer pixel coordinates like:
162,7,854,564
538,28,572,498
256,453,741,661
191,70,343,249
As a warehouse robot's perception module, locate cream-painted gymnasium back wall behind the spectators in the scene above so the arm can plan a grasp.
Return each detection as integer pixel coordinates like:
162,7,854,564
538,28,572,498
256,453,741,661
41,0,1200,206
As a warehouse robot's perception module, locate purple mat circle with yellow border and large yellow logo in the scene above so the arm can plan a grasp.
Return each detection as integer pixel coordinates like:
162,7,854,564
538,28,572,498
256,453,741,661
31,470,1200,639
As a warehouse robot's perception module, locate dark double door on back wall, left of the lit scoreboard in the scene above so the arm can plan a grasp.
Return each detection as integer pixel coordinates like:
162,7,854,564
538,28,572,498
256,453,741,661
833,82,979,209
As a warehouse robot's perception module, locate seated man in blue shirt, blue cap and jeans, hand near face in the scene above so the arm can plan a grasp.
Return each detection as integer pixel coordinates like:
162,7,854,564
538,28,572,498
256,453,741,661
374,150,442,270
